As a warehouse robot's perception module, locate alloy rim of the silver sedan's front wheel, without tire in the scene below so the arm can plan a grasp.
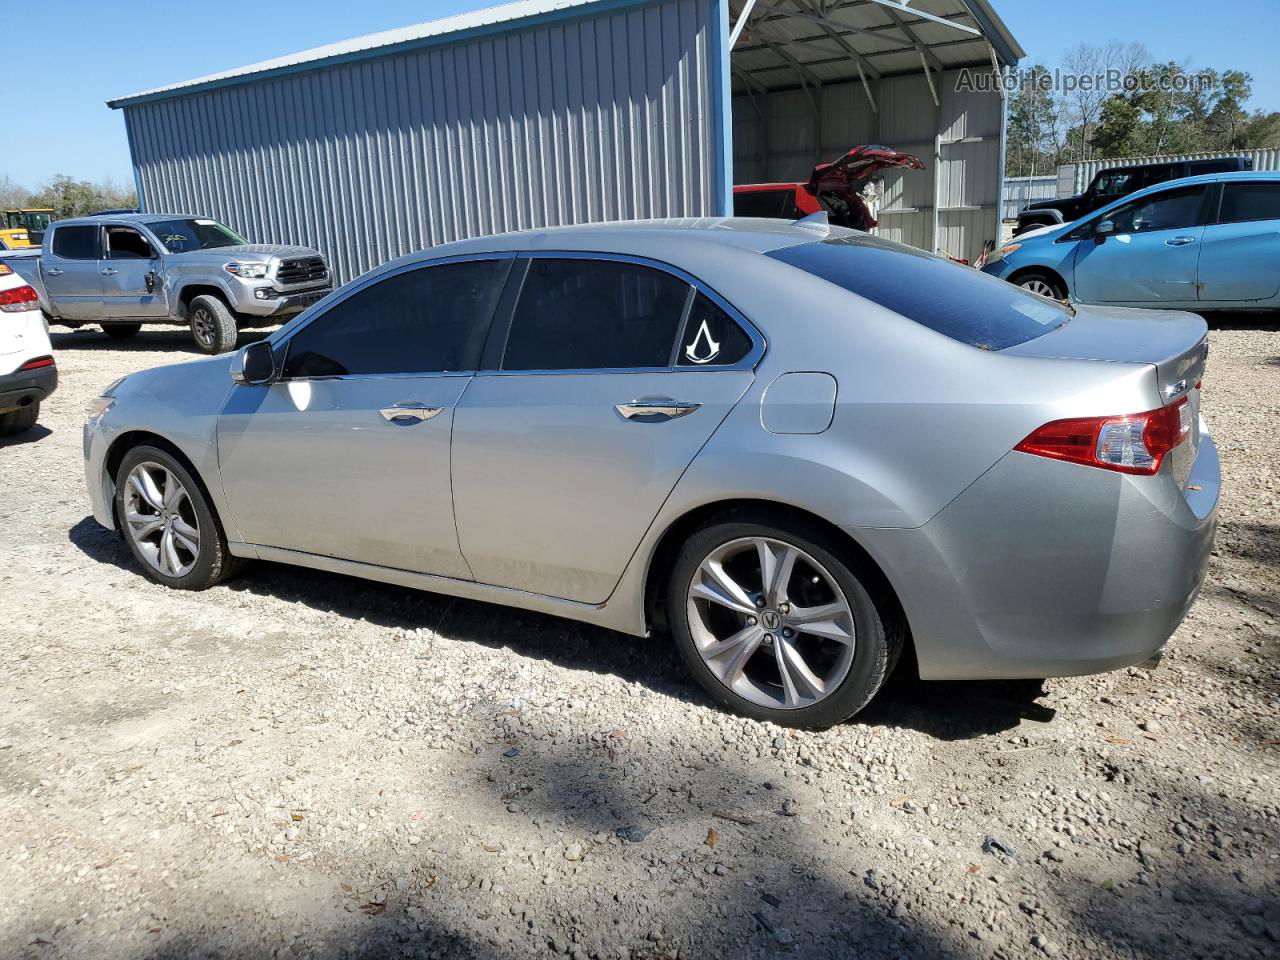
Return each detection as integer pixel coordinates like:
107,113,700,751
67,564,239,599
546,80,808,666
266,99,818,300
124,462,200,577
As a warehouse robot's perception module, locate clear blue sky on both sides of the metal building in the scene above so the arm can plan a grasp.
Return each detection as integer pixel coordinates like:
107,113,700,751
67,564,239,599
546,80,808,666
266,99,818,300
0,0,1280,187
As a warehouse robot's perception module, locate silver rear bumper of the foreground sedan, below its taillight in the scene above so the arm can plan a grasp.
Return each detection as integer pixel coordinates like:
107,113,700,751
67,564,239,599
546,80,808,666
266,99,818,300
850,431,1220,680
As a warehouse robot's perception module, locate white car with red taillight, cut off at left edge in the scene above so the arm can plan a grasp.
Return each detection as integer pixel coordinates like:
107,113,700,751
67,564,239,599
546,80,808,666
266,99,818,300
0,262,58,436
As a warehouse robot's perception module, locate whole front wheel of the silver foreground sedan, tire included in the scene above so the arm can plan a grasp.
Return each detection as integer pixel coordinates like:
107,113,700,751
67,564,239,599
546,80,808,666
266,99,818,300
115,445,242,590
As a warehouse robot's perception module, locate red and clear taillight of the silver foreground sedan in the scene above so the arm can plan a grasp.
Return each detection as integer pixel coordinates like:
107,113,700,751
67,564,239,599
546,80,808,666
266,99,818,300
1014,397,1192,476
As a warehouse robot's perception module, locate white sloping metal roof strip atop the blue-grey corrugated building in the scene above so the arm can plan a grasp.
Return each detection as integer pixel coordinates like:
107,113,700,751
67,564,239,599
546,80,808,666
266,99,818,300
106,0,641,109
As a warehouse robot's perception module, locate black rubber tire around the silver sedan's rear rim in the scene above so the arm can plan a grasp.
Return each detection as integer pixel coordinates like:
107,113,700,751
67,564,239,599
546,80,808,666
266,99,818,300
667,517,904,728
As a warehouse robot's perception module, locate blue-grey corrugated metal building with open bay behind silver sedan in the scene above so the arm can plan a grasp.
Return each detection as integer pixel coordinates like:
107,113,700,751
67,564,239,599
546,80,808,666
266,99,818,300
109,0,1021,280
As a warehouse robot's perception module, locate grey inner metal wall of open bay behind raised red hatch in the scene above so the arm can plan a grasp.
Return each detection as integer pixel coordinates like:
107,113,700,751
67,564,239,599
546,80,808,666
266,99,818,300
733,72,1004,261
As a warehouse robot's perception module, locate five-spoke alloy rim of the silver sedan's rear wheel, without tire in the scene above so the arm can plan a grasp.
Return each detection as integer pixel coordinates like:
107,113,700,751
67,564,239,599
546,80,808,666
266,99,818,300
686,536,855,709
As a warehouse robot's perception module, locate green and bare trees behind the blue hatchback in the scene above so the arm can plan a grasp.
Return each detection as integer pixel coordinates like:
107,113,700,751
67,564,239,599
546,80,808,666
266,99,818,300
1006,42,1280,177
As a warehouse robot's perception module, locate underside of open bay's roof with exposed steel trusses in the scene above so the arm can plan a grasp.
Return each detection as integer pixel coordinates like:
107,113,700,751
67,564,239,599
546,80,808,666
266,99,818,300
730,0,1025,92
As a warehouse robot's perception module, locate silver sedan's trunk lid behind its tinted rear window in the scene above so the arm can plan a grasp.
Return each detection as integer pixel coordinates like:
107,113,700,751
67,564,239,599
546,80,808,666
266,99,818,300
1004,306,1208,484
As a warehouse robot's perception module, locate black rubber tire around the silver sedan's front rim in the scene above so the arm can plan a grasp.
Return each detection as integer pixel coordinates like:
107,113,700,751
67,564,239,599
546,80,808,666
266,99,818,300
115,444,244,590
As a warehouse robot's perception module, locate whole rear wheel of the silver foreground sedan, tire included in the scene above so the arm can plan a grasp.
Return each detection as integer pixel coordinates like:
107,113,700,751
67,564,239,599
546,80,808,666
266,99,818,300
668,520,901,727
